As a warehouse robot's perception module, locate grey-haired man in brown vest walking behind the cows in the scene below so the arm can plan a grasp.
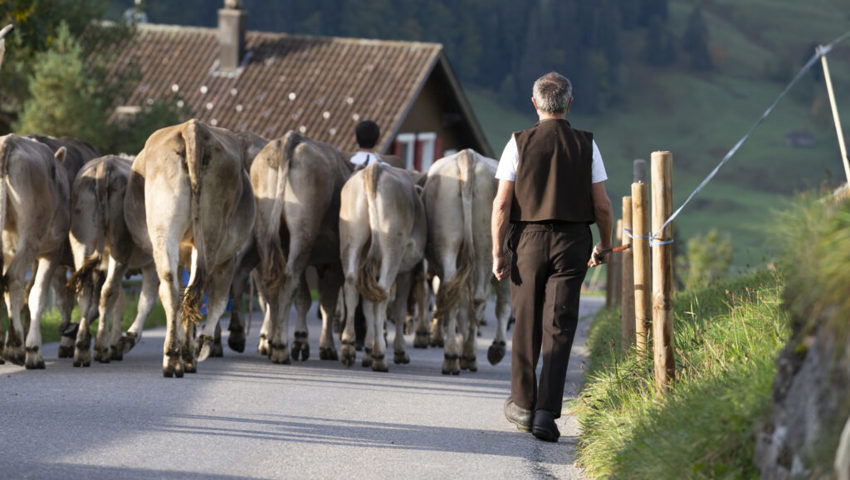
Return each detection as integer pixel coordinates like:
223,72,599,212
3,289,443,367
491,72,612,442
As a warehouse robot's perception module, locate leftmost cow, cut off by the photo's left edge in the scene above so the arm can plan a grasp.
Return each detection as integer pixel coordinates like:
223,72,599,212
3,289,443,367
0,135,70,369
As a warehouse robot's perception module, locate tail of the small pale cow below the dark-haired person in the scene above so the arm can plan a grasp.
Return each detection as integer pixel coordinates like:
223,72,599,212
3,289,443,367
358,164,389,302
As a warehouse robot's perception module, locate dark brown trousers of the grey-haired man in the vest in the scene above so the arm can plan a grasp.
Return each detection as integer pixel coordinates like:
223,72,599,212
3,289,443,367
509,223,593,418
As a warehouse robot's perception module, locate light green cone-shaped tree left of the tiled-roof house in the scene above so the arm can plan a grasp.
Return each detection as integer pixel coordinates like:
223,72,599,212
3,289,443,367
14,22,109,148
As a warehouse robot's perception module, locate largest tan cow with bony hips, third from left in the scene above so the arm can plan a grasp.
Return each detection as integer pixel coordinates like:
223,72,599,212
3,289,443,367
124,119,256,377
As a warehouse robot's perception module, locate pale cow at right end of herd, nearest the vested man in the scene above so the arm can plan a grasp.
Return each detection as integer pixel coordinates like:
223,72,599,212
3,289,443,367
416,149,510,375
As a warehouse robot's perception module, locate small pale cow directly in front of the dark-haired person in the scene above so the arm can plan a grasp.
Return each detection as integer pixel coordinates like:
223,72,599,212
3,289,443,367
339,163,427,372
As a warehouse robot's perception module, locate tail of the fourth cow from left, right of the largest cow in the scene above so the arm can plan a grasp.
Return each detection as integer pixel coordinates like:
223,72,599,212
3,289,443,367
258,131,301,288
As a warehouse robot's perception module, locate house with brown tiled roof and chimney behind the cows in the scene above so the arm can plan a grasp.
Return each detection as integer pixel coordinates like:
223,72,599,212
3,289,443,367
107,1,493,170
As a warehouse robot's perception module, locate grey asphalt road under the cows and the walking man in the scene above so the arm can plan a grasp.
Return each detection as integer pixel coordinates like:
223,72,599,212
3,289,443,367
0,297,604,480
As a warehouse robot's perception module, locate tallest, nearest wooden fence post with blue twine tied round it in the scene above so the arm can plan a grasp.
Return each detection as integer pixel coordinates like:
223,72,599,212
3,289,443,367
652,152,676,392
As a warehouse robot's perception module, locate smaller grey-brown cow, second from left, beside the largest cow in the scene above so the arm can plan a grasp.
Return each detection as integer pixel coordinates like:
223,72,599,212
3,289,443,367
69,155,157,367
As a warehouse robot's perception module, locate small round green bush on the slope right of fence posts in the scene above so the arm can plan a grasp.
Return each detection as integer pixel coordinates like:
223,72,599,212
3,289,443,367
677,229,732,289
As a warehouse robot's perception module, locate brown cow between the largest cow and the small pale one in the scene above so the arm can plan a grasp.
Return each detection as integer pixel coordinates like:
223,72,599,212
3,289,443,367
251,131,352,363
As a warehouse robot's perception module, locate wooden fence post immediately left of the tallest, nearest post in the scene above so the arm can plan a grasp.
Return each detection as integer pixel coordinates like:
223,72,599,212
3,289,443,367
632,182,652,352
